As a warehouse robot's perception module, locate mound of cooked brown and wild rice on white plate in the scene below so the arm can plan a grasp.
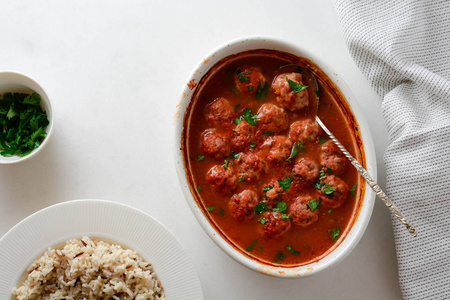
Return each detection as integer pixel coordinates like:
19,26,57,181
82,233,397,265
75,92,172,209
12,237,165,300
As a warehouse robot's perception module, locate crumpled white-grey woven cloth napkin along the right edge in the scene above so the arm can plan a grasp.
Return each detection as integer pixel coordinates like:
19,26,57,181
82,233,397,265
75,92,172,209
336,0,450,299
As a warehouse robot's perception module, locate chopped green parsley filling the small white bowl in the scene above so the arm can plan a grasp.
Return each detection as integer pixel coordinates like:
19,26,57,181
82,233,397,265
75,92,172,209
0,93,49,156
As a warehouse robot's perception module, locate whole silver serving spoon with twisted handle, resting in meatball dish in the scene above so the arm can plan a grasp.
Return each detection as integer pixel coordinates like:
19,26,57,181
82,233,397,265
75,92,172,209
277,65,417,237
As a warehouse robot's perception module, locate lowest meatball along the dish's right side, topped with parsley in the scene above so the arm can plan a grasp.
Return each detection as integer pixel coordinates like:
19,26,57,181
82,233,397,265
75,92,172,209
317,175,348,208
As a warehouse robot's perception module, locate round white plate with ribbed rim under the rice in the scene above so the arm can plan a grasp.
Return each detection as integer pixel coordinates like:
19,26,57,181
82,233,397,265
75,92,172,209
0,200,203,300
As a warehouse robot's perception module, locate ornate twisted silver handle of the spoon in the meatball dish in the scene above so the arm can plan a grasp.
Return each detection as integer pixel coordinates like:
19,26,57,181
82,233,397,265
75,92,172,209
316,116,417,237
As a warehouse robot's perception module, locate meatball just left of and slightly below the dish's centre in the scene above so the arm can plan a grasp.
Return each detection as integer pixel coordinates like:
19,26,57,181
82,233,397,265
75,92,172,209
231,152,267,181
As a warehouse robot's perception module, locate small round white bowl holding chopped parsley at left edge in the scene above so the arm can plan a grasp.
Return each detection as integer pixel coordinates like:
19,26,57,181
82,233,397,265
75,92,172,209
0,71,54,164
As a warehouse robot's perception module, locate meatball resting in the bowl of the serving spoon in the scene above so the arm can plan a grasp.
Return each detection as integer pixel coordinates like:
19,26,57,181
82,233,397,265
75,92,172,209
272,73,309,111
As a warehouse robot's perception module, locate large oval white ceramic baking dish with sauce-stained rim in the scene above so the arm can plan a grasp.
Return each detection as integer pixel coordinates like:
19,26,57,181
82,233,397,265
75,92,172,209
174,37,376,278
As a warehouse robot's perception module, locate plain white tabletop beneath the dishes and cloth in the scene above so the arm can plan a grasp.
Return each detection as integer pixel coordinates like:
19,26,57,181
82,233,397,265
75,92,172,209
0,0,401,300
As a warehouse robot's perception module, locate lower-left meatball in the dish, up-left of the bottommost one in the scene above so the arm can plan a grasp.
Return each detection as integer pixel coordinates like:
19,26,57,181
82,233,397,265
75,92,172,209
228,190,259,221
